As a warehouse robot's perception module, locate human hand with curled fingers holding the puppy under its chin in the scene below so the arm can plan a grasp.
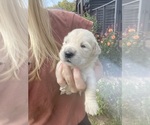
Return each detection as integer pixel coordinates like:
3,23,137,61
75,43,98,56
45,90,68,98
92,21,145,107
56,61,86,94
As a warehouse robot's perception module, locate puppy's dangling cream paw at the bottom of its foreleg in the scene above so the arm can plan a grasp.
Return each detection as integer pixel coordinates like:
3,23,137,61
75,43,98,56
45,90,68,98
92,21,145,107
85,100,99,115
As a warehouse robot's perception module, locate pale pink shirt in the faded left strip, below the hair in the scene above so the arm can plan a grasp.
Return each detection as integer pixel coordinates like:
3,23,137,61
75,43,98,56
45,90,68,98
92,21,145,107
0,34,28,125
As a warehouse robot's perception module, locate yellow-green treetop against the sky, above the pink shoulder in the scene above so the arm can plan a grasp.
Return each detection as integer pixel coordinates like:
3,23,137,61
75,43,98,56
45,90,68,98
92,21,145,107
53,0,76,11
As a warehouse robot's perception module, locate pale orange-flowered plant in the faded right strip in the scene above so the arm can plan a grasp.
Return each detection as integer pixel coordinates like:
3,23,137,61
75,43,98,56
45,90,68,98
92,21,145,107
122,28,147,64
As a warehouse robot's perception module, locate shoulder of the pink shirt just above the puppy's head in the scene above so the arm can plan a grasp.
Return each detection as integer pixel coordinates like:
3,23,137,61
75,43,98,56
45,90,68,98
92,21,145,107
48,9,93,43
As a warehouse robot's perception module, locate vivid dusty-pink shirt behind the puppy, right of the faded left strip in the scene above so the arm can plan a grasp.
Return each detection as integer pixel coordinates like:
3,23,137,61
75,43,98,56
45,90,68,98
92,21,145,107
29,9,93,125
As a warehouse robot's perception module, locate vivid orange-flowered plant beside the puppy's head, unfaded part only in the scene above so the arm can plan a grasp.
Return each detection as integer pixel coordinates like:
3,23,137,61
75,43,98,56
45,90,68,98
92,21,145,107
95,28,121,65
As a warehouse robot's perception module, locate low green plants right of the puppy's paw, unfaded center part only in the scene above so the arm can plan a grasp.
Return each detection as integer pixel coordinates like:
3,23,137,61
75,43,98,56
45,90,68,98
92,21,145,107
89,78,121,125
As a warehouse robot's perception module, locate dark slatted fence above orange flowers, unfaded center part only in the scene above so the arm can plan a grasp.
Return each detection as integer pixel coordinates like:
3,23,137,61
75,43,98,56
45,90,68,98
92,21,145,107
92,0,122,34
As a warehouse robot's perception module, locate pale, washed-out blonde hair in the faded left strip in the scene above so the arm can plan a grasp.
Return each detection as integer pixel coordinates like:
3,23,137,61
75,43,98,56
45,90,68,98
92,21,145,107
0,0,28,82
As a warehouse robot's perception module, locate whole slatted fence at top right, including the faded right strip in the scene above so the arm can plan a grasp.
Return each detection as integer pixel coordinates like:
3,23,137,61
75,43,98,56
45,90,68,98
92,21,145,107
92,0,150,33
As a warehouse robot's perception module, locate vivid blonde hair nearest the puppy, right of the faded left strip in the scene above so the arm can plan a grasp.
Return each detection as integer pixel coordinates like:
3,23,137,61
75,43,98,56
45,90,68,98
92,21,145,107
28,0,58,80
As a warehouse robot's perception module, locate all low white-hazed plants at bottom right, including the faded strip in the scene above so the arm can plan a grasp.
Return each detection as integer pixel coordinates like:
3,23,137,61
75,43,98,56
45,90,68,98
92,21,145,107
90,77,150,125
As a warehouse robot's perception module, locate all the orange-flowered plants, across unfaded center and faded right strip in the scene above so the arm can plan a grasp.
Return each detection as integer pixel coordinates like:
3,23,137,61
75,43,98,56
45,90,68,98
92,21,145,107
95,28,145,63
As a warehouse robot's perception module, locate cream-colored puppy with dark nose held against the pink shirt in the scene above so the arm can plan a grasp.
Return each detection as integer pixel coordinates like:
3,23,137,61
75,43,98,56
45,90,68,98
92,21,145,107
56,29,101,115
